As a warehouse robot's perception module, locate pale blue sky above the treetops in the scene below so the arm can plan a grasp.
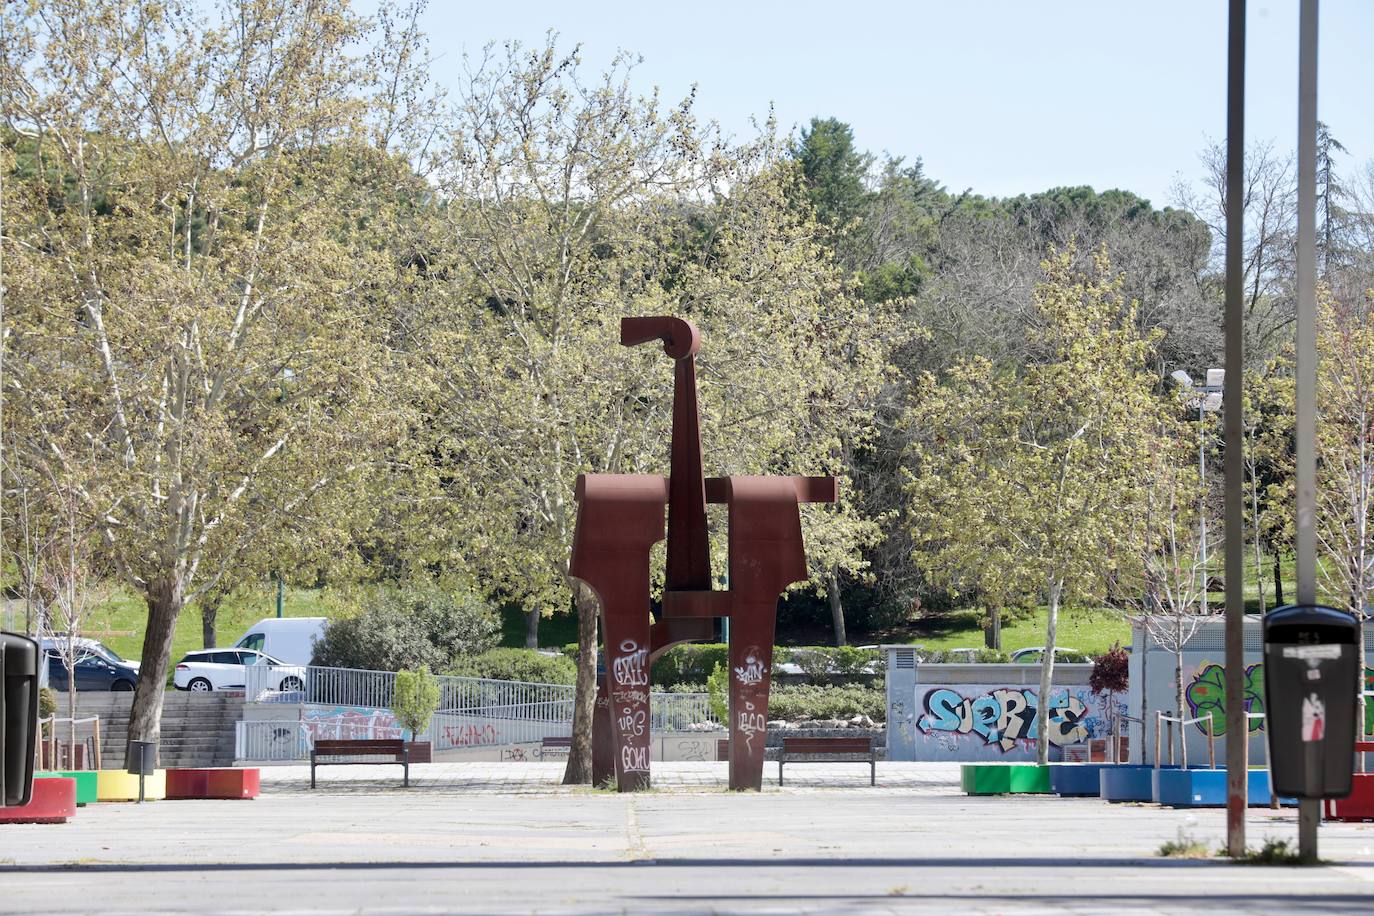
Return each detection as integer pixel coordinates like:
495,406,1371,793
390,0,1374,205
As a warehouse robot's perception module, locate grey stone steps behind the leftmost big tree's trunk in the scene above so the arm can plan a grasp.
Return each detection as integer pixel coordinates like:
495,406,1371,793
68,689,243,769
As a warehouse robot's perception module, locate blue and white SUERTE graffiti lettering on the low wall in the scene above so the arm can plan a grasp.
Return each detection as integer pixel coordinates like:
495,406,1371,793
916,687,1092,751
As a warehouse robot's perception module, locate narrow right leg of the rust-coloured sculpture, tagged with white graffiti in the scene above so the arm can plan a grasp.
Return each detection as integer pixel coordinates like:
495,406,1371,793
730,599,778,792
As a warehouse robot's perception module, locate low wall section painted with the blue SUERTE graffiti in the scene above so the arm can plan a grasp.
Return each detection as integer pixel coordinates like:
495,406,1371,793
915,684,1125,761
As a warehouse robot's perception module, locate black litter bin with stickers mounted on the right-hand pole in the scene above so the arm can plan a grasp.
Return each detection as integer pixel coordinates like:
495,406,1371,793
1264,604,1360,798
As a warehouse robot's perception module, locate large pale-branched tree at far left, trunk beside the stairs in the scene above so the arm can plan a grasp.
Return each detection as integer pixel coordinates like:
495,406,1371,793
0,0,414,758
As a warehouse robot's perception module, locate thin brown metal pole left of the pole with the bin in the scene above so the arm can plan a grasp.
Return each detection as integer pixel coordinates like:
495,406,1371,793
1221,0,1249,858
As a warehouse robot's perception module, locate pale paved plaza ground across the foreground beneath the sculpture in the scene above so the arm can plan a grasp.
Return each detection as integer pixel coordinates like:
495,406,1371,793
0,764,1374,913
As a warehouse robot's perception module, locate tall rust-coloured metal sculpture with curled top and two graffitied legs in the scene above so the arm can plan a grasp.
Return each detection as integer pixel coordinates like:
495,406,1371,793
570,317,835,792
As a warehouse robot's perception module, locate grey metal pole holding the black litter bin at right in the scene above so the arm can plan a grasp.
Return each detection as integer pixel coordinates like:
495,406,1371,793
1297,0,1322,862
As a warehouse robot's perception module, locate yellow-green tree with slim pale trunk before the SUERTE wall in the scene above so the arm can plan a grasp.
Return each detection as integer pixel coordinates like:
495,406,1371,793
907,249,1161,764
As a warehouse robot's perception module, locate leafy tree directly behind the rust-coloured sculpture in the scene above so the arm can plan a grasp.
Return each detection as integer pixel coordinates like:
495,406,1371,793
412,43,886,783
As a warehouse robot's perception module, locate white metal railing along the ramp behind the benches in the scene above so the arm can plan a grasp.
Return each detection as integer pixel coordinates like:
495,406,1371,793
235,666,719,761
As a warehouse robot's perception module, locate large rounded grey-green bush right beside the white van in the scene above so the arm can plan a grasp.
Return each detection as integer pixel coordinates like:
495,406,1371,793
311,584,500,672
